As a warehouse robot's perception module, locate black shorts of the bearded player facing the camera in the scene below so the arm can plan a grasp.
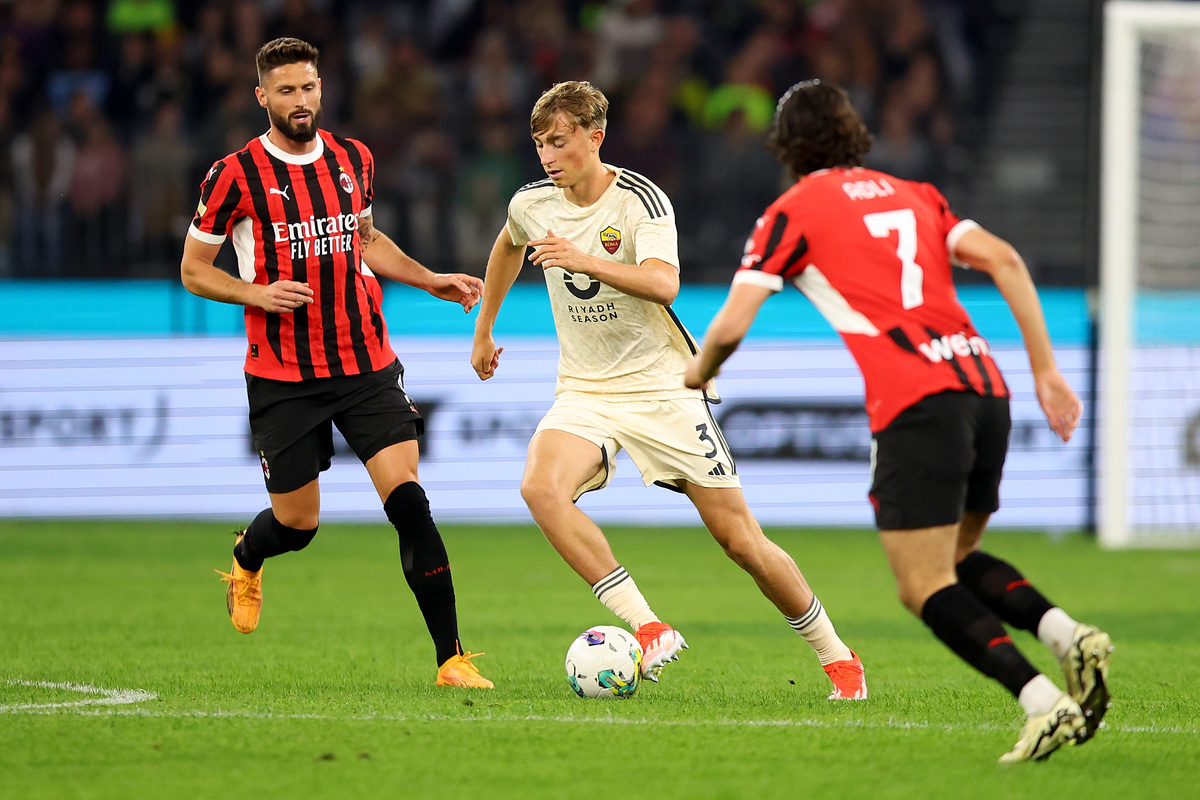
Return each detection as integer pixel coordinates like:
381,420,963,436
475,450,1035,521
246,361,425,494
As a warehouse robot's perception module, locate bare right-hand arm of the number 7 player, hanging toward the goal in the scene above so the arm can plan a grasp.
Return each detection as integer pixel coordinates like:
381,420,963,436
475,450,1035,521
954,228,1084,441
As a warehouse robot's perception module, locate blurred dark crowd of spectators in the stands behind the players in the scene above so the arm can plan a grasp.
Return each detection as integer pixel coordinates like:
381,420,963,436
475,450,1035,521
0,0,1013,282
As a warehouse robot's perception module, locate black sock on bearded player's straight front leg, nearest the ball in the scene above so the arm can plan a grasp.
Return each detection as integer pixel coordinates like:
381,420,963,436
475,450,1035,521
383,481,458,666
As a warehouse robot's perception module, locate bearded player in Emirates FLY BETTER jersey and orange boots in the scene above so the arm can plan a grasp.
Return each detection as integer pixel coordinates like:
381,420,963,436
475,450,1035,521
181,38,492,688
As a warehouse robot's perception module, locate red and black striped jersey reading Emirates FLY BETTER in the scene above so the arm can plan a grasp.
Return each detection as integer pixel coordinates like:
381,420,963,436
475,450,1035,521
188,131,396,381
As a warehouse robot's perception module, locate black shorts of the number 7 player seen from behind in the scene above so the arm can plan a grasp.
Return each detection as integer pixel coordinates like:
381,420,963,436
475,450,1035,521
870,391,1013,530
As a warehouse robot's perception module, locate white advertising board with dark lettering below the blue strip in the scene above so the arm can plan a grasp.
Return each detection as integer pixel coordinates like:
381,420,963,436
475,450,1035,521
0,337,1087,528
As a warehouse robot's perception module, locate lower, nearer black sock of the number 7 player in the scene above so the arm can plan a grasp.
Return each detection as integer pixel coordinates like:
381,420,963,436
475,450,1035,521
920,584,1039,697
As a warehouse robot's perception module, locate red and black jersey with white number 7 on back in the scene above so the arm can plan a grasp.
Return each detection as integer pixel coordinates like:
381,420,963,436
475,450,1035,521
733,168,1008,431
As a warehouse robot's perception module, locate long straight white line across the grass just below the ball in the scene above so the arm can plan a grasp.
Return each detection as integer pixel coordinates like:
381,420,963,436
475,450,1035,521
0,705,1200,736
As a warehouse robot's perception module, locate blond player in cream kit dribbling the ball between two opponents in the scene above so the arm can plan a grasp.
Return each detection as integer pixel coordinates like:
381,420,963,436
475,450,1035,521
472,82,866,699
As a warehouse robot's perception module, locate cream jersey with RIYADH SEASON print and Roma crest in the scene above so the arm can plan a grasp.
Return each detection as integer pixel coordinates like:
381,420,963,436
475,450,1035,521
508,164,715,399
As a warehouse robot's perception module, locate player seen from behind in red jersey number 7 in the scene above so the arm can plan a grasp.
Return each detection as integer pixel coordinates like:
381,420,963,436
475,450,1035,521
685,80,1112,762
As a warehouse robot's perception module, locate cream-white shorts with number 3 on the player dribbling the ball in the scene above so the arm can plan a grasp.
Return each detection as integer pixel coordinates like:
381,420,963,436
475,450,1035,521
534,392,742,499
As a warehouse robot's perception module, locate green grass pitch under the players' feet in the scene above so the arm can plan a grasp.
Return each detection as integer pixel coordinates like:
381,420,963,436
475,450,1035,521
0,521,1200,800
